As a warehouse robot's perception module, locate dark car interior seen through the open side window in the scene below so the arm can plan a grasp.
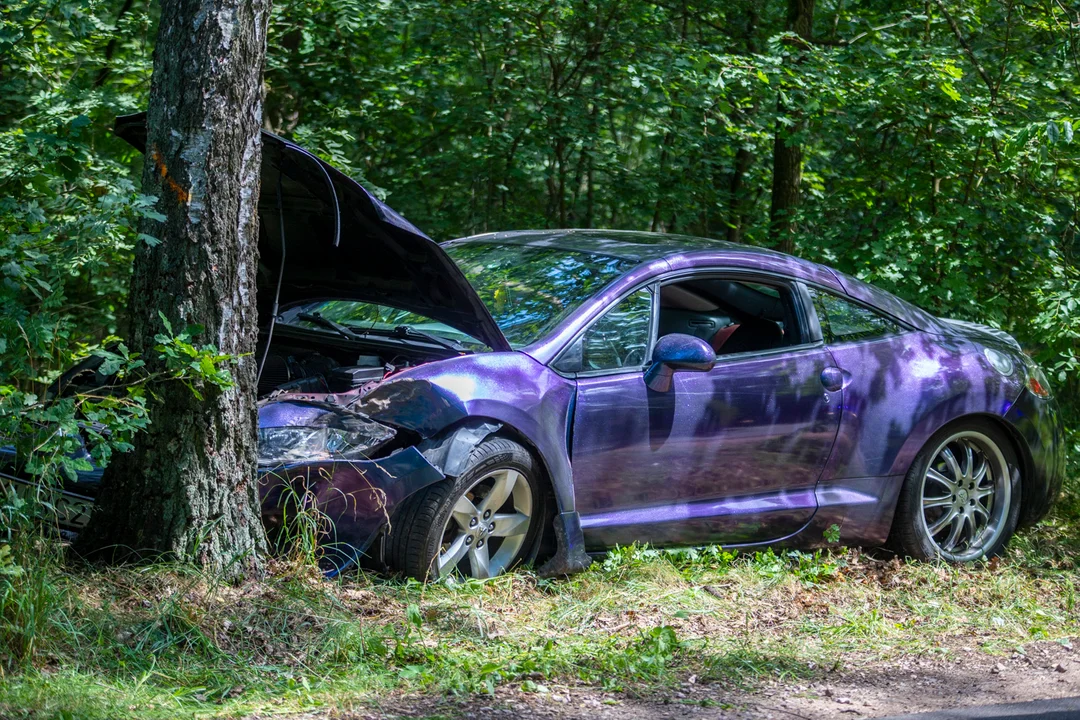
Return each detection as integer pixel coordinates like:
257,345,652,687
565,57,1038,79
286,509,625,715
659,277,802,356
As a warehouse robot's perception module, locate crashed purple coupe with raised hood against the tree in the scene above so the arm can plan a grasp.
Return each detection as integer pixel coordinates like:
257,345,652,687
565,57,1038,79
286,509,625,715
8,117,1065,580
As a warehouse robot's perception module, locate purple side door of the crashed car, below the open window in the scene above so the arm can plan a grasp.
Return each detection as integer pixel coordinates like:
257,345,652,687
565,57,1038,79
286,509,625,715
563,273,840,547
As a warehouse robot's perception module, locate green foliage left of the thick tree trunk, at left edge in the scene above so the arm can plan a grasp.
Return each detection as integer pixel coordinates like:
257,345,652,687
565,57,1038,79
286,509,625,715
0,0,230,549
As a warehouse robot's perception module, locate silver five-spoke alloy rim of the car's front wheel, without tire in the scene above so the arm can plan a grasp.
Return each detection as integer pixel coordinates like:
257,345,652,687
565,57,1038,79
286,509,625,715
433,467,532,579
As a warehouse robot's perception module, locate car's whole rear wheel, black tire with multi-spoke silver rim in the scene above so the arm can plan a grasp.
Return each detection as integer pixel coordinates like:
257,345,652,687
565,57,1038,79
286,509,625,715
889,419,1021,562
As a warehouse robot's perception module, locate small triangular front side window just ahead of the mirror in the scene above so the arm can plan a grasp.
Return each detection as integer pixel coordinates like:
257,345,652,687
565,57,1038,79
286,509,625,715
554,288,652,372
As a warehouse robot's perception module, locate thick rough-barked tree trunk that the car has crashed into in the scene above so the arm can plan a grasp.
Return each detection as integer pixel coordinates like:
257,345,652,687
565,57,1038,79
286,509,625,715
80,0,269,579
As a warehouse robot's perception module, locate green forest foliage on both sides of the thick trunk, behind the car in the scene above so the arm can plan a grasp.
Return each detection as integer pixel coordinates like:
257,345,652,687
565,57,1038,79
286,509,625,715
0,0,1080,509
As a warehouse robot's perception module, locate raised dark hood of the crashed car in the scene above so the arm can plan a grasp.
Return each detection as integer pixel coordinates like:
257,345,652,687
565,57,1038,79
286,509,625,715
114,112,510,350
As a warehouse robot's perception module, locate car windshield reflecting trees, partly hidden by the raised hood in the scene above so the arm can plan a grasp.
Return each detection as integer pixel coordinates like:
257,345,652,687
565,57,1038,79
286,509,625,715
281,243,635,350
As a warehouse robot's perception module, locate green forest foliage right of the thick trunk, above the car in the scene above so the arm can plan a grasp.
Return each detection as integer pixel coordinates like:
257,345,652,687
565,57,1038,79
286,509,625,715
267,0,1080,404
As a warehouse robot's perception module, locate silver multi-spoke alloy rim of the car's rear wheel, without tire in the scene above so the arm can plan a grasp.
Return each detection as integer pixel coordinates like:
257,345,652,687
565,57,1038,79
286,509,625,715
920,431,1012,562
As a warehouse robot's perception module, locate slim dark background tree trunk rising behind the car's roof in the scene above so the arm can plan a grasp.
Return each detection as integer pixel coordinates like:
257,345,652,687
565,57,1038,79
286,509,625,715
769,0,814,253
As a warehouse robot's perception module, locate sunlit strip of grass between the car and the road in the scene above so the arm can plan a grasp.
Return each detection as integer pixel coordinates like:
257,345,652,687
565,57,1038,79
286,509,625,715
0,472,1080,718
